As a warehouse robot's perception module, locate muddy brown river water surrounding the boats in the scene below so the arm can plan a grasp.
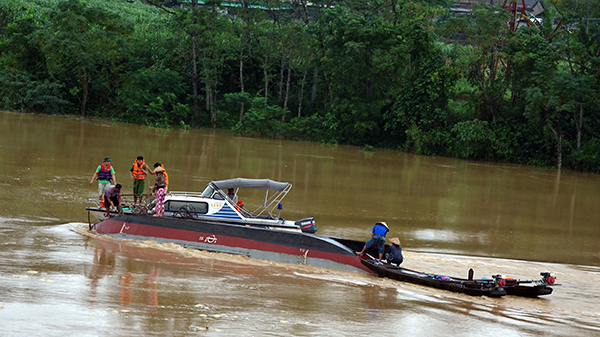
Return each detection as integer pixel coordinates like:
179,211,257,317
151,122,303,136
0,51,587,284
0,112,600,336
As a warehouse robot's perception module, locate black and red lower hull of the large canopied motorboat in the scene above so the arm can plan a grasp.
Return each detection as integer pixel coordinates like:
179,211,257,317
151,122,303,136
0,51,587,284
92,215,371,272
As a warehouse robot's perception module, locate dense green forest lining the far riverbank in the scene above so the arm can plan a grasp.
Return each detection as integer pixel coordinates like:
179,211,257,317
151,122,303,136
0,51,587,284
0,0,600,172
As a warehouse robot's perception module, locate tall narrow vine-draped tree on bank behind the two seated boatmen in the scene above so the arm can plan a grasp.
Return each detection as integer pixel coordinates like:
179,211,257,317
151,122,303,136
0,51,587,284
385,5,451,154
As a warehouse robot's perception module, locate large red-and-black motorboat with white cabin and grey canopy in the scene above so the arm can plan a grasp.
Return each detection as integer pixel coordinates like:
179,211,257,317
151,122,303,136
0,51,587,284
86,178,376,272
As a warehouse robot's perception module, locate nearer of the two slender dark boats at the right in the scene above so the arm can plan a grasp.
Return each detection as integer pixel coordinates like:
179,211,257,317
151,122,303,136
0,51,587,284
361,260,506,297
